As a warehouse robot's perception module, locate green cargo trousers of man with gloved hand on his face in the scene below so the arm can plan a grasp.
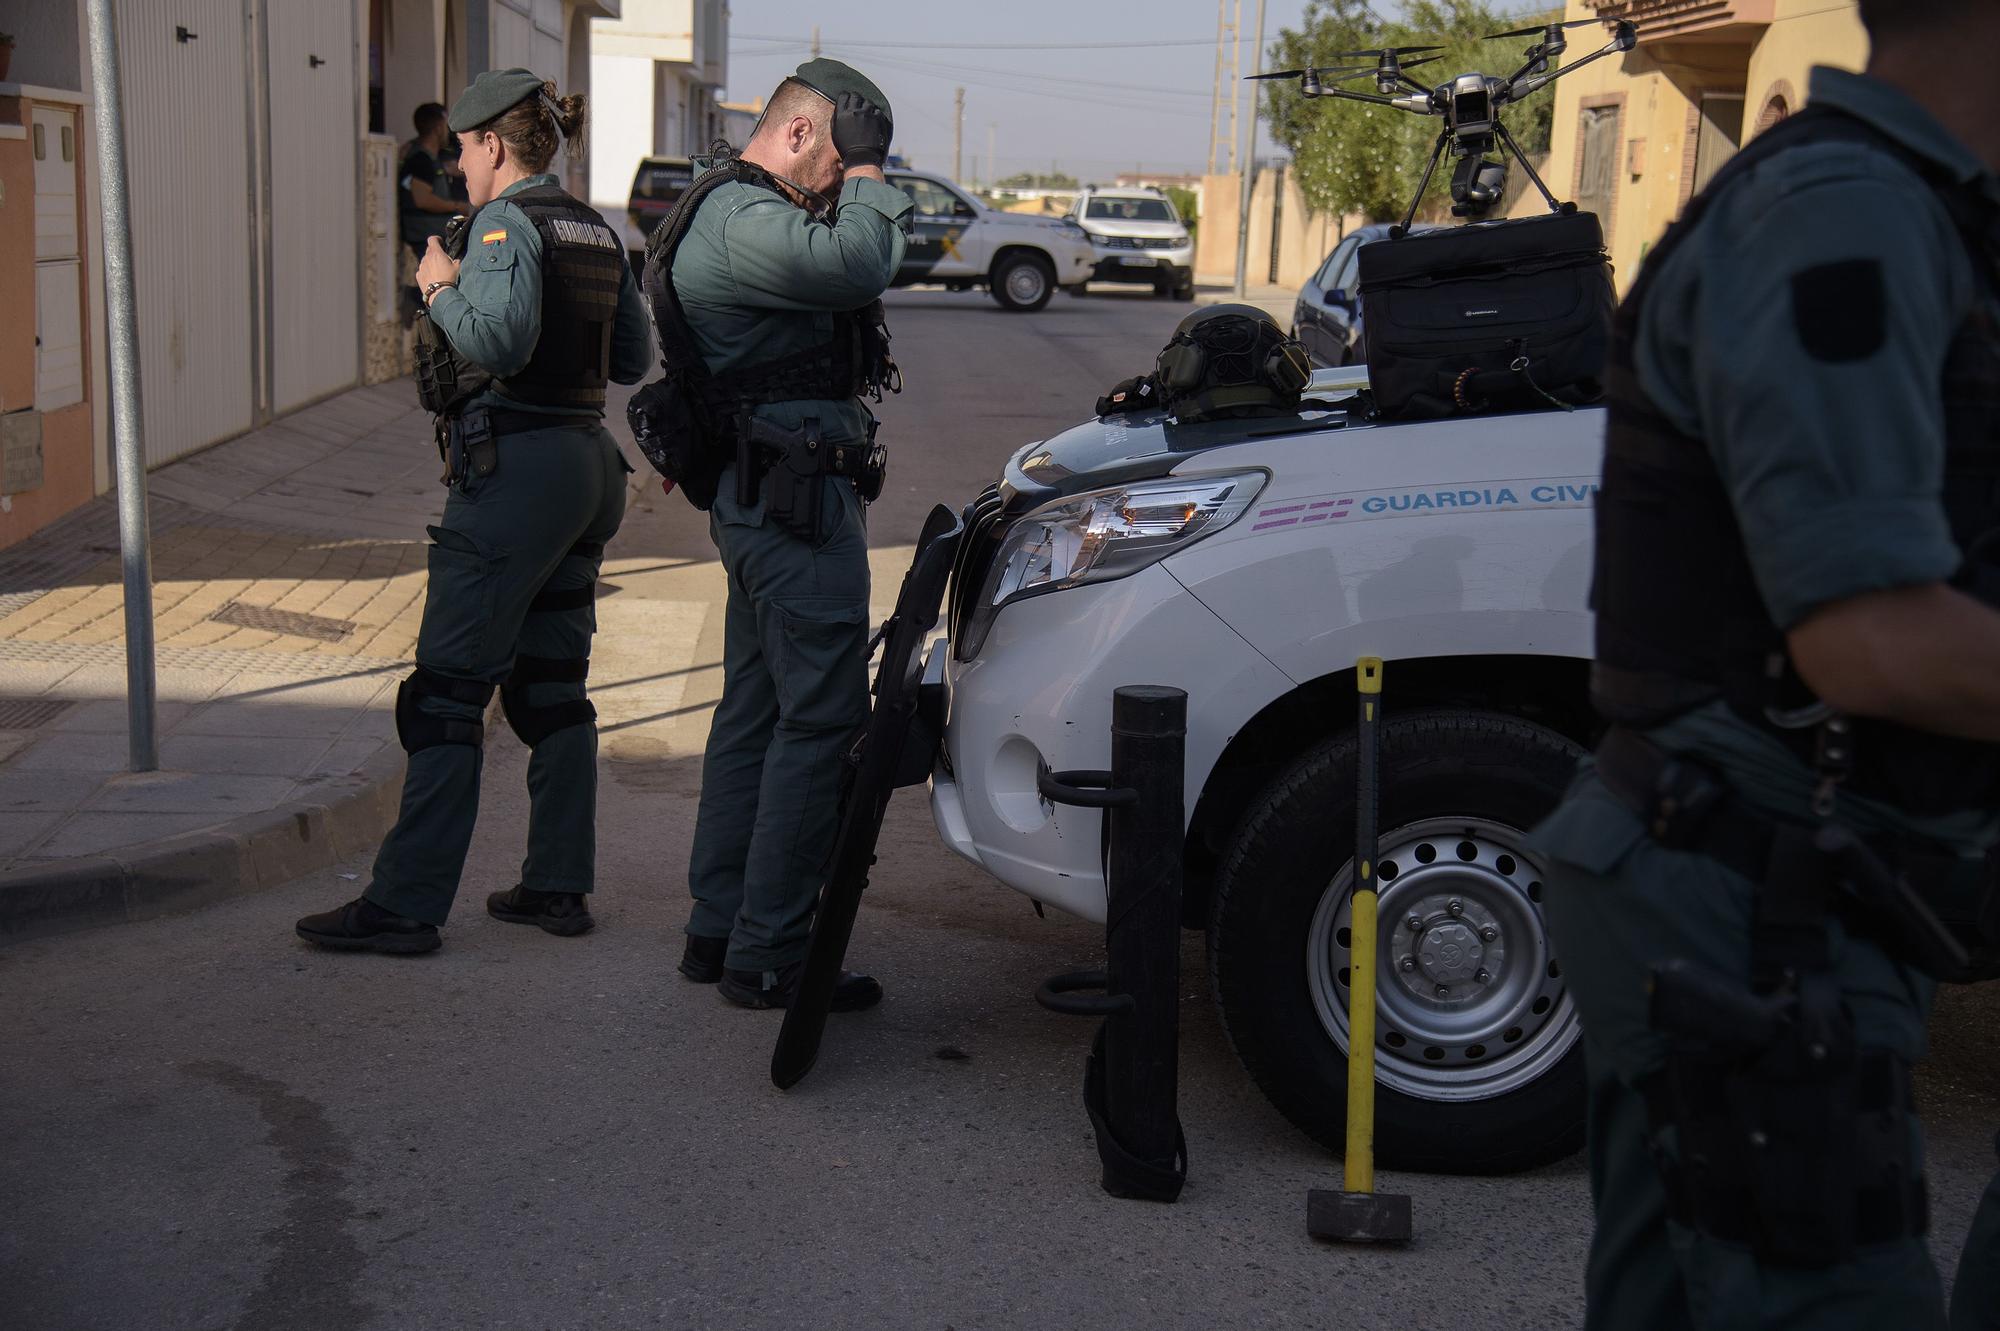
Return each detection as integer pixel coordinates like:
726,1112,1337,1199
688,468,868,971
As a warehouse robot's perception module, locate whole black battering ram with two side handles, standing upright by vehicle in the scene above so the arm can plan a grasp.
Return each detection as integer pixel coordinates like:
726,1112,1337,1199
1036,683,1188,1201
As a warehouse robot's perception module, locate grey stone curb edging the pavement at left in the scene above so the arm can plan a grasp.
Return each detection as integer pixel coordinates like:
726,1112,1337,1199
0,743,406,945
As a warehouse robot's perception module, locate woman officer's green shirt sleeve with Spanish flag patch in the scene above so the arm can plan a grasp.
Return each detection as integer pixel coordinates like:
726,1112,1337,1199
430,200,542,378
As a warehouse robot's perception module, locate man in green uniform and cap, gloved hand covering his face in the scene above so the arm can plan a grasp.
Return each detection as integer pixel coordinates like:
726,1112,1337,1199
648,60,910,1009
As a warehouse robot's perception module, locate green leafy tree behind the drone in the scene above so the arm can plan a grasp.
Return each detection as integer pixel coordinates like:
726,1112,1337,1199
1264,0,1560,222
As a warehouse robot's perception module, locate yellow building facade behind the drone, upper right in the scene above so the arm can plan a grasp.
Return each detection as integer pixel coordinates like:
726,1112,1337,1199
1512,0,1868,290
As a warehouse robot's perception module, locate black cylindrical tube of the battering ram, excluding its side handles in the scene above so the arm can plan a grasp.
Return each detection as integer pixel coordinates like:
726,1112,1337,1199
1104,685,1188,1165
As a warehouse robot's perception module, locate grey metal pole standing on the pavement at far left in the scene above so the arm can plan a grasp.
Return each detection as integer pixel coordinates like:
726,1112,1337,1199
84,0,160,771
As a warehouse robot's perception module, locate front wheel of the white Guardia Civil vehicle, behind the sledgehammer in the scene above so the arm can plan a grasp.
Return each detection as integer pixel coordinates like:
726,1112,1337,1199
1208,709,1584,1173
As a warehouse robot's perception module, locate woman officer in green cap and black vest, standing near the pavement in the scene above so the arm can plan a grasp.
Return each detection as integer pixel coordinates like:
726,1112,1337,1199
298,70,652,953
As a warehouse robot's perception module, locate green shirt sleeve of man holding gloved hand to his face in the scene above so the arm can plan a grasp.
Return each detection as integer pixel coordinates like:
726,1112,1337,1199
722,178,910,310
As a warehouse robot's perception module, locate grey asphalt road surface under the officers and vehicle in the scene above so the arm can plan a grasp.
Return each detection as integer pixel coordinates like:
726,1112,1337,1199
0,292,2000,1331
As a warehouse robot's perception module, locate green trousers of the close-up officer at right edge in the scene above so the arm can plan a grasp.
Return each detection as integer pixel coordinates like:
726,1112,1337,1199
1536,773,1944,1331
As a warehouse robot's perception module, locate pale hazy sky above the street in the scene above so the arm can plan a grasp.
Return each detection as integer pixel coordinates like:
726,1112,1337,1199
728,0,1306,184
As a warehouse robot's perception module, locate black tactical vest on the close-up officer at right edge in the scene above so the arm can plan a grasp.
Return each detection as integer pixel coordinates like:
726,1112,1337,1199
1590,108,2000,815
